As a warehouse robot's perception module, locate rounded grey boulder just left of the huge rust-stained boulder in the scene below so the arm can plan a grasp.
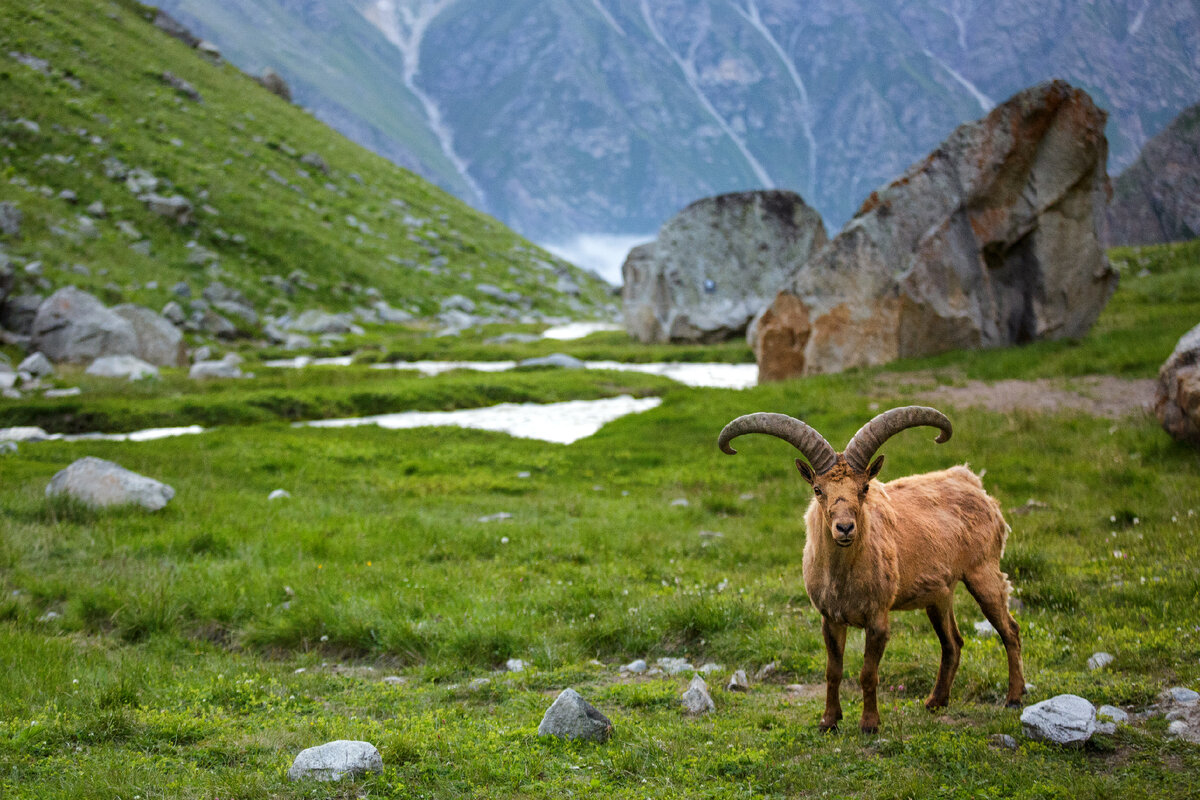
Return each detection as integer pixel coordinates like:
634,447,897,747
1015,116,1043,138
622,190,827,342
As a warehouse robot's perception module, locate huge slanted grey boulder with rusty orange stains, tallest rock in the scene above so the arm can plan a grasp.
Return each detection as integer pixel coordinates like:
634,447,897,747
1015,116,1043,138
754,80,1117,380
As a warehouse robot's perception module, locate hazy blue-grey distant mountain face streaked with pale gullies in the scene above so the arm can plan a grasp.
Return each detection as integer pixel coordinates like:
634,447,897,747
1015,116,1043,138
152,0,1200,250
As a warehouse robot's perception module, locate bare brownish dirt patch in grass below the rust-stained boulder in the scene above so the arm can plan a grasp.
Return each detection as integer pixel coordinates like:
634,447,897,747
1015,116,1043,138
878,375,1154,420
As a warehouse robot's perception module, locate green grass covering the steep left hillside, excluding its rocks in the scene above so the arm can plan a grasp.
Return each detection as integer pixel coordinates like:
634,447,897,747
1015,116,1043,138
0,0,611,326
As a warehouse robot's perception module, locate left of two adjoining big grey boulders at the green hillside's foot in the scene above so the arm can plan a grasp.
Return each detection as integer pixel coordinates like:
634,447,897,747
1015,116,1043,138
30,287,138,363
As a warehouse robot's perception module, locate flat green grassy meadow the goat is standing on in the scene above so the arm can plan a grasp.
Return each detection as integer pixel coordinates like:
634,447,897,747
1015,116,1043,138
0,243,1200,800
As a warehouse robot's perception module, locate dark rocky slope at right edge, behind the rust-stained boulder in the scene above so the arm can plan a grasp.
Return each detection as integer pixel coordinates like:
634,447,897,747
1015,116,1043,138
1108,106,1200,245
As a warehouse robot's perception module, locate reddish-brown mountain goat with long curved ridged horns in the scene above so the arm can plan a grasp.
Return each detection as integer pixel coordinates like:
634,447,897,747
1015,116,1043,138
718,405,1025,733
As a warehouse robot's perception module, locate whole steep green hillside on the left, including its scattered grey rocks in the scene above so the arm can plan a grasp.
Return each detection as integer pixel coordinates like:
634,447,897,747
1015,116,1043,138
0,0,616,352
